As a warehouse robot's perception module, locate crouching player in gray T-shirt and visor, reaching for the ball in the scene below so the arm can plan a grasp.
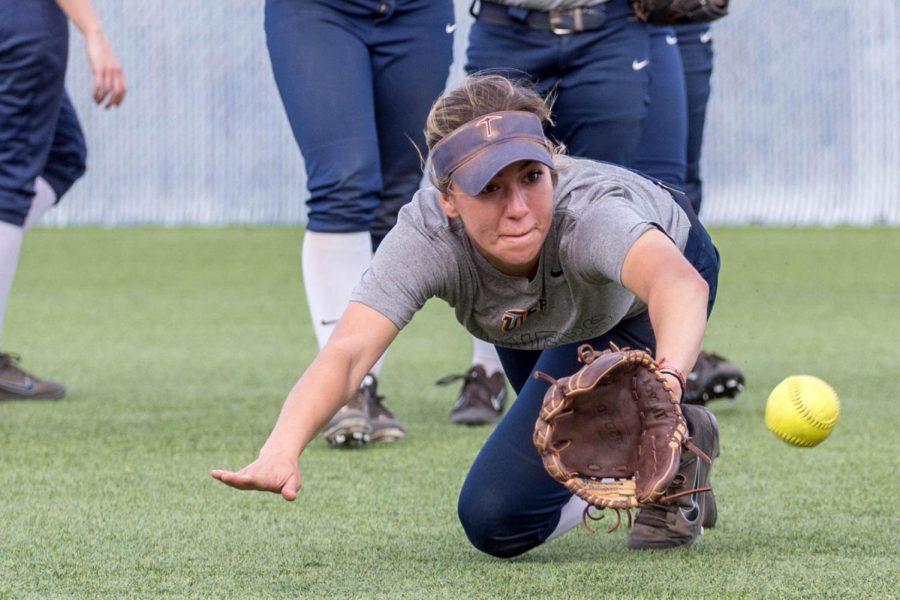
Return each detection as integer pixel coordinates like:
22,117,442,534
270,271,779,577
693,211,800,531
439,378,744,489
211,76,719,557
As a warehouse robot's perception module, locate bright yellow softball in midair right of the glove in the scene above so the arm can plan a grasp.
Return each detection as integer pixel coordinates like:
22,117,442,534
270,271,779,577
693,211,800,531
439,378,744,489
766,375,841,448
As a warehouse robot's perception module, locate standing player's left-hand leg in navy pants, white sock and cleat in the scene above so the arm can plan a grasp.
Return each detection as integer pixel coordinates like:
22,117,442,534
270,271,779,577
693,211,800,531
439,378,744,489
265,0,381,443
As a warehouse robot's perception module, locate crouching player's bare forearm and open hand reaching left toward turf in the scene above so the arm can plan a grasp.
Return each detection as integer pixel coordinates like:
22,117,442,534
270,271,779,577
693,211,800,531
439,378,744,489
210,302,400,500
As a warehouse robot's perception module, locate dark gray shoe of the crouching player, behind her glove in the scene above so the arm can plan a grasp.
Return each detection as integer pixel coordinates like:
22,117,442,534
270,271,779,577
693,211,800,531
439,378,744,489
627,405,719,550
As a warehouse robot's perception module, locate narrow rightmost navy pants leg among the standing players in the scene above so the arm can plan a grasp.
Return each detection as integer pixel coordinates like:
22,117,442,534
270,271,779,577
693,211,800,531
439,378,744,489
675,23,713,215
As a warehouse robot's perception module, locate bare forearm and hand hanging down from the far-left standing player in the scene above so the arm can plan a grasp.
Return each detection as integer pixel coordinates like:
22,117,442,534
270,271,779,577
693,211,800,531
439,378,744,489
56,0,127,108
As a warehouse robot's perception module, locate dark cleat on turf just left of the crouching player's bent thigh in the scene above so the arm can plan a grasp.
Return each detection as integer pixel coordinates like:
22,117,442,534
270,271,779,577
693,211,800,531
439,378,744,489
435,365,507,425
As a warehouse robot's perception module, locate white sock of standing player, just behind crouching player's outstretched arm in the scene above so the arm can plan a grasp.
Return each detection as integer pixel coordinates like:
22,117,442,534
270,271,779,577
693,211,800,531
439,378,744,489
302,231,372,349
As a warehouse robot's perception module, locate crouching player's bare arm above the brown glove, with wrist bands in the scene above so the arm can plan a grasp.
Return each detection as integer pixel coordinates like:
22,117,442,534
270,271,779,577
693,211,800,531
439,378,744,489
622,229,709,394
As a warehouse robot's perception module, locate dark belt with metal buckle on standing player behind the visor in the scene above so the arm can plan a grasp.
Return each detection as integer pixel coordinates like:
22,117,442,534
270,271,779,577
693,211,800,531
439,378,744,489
472,0,632,35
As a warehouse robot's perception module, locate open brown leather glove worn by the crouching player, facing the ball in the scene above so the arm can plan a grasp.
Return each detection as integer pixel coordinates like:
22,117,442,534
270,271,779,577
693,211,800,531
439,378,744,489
534,344,703,531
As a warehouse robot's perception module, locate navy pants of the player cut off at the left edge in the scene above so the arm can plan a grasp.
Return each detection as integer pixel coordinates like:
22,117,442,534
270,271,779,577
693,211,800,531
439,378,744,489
0,0,86,226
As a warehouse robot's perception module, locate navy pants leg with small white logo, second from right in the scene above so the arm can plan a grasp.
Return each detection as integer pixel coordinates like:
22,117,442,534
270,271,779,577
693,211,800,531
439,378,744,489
634,27,687,188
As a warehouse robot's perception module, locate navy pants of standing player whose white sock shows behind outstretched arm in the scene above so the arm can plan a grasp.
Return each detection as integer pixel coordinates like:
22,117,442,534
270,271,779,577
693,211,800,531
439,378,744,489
265,0,453,244
